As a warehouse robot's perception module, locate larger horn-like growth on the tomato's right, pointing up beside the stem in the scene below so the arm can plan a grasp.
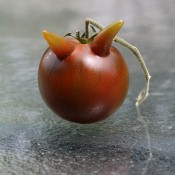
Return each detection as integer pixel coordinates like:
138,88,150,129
91,20,124,57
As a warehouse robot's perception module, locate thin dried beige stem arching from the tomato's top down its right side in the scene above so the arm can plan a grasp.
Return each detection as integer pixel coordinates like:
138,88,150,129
85,18,151,106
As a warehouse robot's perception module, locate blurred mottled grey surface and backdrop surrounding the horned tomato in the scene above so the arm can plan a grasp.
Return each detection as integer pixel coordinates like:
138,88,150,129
0,0,175,175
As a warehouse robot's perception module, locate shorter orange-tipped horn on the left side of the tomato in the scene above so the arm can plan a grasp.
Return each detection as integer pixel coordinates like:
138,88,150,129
43,31,74,60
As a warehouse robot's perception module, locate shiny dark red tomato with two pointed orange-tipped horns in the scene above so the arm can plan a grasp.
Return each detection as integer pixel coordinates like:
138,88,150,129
38,21,129,123
